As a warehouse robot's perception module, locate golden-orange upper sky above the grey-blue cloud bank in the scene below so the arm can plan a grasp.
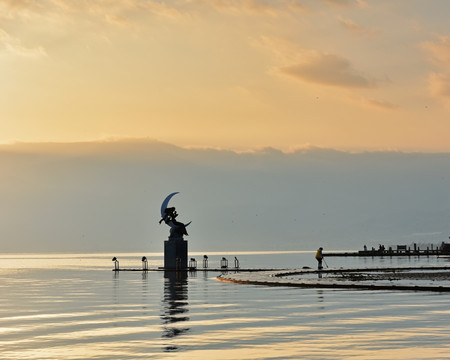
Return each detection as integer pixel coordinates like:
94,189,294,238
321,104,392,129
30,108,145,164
0,0,450,152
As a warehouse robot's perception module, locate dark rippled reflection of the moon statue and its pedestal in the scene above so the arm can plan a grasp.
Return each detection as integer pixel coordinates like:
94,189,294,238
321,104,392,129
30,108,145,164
161,271,189,352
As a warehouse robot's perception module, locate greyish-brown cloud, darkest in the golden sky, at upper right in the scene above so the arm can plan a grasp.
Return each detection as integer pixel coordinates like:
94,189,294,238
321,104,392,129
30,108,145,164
279,53,375,88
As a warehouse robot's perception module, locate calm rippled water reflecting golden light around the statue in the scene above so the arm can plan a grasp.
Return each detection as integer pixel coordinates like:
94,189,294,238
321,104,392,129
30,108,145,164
0,253,450,360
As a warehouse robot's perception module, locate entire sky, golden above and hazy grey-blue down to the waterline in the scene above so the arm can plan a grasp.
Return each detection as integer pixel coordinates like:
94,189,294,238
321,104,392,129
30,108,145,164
0,0,450,252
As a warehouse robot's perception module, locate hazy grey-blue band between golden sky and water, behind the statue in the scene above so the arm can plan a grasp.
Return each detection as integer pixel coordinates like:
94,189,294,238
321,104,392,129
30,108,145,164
0,139,450,252
